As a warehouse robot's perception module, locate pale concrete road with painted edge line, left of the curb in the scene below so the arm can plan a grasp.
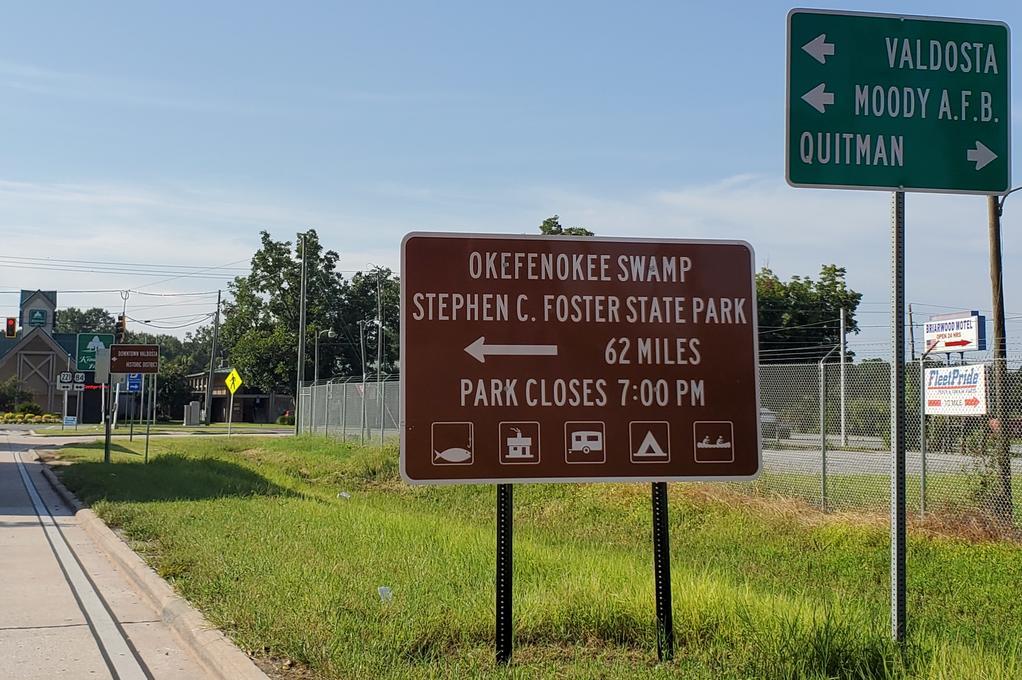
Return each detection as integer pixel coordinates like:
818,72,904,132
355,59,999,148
0,433,207,680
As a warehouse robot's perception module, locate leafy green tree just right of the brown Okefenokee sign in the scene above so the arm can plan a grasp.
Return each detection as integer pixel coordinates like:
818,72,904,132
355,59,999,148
756,265,863,364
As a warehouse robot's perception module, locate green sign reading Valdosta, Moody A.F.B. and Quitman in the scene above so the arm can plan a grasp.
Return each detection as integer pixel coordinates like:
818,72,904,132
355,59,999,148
786,9,1011,193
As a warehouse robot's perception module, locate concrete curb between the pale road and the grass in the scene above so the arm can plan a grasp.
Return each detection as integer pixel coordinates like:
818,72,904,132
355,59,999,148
40,454,268,680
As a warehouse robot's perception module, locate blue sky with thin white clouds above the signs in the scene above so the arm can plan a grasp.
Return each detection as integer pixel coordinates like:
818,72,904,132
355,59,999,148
0,2,1022,354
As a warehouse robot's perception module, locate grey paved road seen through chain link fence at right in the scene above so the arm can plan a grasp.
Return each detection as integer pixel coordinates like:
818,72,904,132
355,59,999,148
763,443,1022,474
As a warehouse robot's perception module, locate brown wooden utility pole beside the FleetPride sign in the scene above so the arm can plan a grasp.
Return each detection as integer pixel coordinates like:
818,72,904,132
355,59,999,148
986,192,1014,525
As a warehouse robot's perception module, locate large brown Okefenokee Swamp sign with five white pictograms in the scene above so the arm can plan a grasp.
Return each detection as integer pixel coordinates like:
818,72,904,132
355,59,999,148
401,233,760,484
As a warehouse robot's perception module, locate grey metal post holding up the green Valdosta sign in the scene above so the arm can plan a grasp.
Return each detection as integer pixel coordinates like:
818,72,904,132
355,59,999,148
891,191,905,642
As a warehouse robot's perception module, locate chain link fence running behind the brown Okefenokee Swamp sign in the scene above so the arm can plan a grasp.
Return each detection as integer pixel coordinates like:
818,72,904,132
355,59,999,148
299,359,1022,528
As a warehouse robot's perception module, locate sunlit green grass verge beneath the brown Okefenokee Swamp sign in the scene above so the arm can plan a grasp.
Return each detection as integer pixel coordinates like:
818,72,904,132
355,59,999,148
51,438,1022,679
